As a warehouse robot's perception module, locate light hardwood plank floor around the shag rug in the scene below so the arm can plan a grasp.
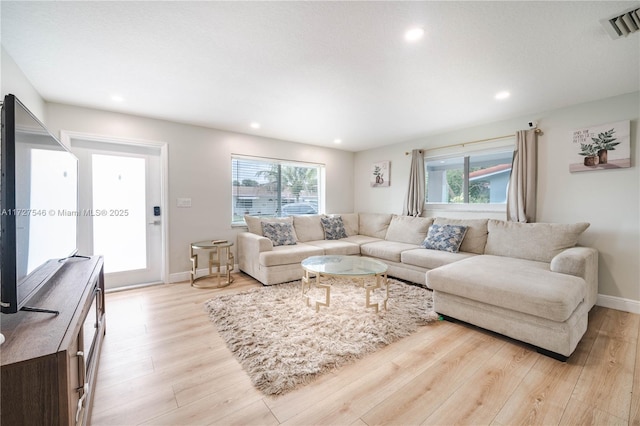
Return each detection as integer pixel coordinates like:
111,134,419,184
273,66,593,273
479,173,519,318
90,273,640,425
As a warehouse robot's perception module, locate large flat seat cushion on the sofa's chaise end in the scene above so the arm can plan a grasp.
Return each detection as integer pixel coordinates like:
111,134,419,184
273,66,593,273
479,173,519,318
426,255,586,322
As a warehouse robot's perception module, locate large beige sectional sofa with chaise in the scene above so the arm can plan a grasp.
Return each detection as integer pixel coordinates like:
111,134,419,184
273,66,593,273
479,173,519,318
237,213,598,358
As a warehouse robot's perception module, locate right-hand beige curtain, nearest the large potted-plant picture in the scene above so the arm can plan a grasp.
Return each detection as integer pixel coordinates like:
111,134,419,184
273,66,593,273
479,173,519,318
507,129,538,222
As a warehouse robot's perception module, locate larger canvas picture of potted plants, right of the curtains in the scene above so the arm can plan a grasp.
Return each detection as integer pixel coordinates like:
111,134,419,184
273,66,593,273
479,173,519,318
569,120,631,172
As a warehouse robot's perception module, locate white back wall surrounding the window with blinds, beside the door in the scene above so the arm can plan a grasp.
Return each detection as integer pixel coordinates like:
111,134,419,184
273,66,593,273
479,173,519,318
46,103,354,278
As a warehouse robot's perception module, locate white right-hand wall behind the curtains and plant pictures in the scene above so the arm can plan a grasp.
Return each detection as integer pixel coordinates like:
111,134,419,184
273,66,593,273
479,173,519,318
354,92,640,311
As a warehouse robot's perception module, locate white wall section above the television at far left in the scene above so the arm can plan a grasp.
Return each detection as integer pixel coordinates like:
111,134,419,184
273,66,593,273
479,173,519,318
0,46,46,123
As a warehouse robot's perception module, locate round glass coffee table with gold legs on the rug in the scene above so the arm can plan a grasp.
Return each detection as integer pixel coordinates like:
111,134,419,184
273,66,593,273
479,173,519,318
302,255,389,312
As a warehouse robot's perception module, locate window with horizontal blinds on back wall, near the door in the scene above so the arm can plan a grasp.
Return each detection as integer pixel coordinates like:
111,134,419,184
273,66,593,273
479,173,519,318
231,156,324,224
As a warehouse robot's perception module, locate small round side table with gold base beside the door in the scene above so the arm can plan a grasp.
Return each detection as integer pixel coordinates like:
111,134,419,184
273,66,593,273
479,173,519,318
189,240,234,288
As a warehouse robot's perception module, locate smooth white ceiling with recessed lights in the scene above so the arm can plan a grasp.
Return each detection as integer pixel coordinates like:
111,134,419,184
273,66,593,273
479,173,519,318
0,0,640,151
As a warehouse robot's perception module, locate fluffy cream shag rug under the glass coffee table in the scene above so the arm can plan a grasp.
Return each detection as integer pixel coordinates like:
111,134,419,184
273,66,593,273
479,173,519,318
205,279,438,395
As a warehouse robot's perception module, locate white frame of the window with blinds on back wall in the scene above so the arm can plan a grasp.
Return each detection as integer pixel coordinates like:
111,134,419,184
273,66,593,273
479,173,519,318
231,154,326,227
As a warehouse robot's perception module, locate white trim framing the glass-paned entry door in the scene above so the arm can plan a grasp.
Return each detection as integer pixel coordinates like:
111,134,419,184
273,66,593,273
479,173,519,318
60,130,169,291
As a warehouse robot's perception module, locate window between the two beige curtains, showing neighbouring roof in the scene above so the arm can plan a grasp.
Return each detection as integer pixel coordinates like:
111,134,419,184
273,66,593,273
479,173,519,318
425,148,513,204
